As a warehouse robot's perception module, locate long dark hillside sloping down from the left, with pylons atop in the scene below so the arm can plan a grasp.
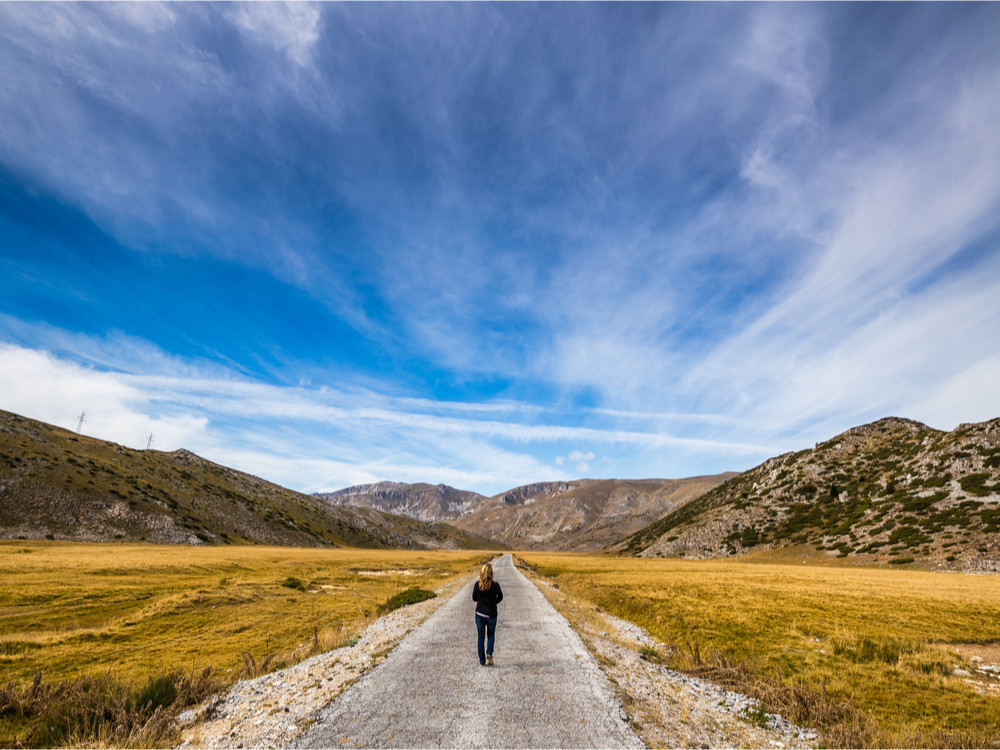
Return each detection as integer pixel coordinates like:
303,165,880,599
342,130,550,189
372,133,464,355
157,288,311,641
0,411,495,549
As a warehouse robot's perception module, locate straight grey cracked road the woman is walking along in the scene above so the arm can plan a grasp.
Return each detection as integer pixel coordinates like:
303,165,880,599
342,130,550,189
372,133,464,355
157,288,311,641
294,555,644,748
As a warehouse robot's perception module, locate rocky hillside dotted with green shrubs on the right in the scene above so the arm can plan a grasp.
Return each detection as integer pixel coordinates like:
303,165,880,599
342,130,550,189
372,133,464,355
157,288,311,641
613,417,1000,571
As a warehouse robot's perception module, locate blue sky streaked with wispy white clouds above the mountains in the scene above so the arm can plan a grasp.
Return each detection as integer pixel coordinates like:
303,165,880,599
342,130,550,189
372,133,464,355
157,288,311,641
0,3,1000,494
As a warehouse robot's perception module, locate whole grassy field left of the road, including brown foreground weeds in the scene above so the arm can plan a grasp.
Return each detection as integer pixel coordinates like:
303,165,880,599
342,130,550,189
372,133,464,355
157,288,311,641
0,542,492,747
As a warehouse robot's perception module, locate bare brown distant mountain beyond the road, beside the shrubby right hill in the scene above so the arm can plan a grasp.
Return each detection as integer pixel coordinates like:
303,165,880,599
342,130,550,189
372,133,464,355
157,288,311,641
453,474,733,552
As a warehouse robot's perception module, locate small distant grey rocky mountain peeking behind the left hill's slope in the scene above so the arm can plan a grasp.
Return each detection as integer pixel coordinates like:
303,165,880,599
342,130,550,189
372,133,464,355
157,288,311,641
313,482,486,521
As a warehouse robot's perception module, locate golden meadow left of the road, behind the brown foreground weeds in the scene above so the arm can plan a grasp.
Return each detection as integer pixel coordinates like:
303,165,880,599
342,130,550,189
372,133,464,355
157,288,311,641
0,542,488,682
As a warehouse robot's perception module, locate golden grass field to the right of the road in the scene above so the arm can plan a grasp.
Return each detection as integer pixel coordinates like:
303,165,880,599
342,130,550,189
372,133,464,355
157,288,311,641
519,552,1000,747
